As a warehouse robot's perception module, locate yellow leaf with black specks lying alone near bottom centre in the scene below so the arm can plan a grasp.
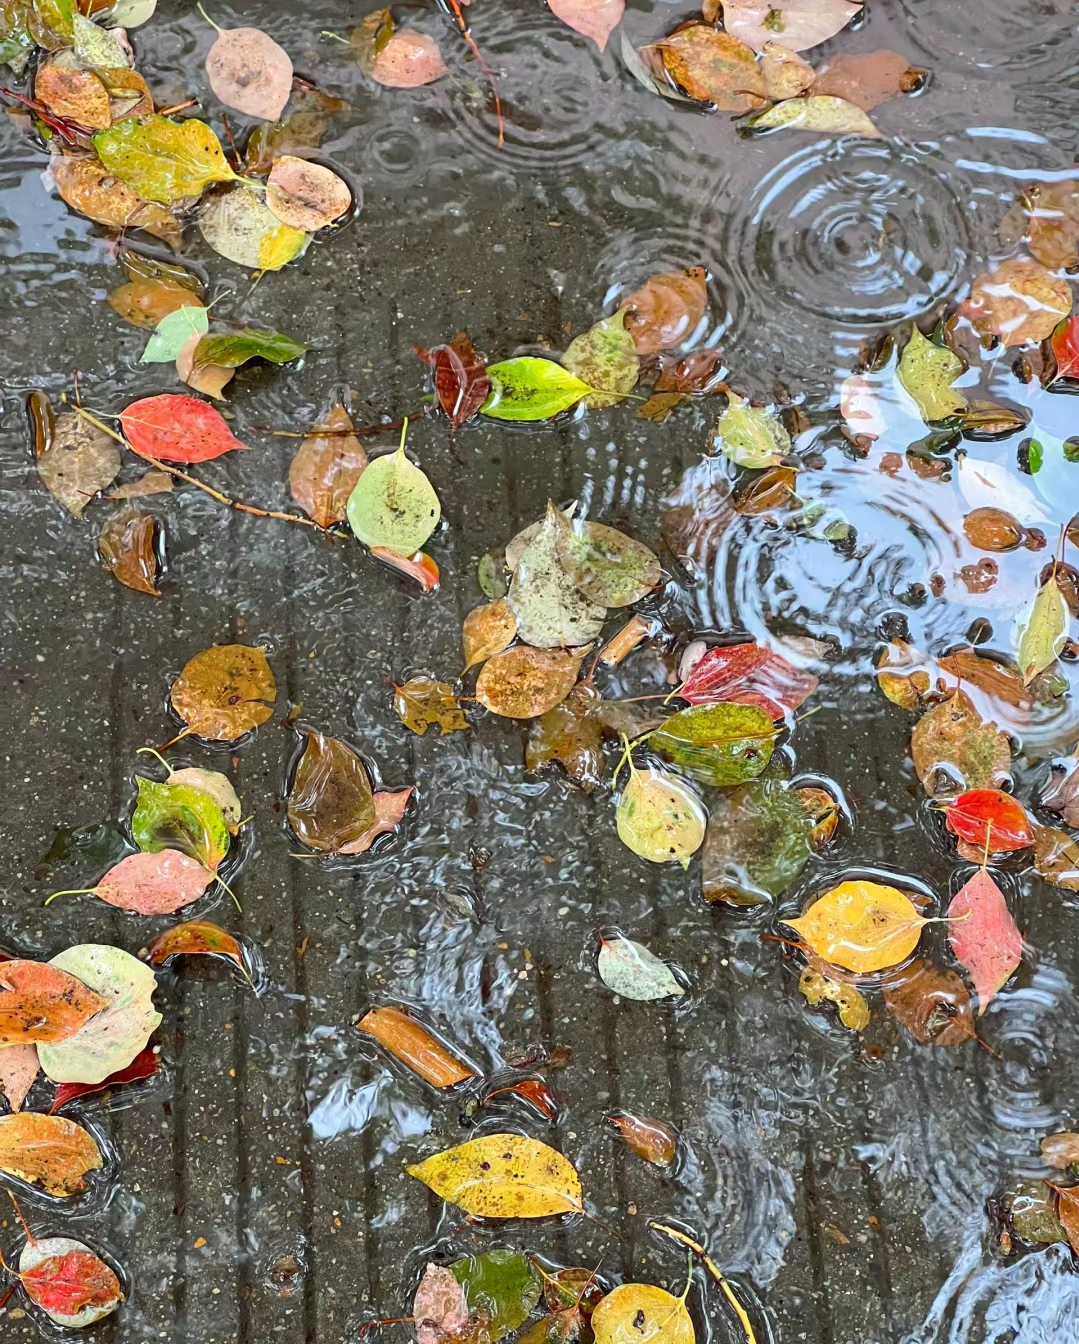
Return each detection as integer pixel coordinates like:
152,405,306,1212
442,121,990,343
407,1134,583,1218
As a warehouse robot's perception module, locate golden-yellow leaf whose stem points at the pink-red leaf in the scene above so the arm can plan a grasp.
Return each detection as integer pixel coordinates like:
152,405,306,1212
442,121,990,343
782,882,926,974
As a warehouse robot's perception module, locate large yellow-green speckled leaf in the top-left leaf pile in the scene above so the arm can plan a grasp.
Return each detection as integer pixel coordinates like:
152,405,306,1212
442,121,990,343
94,113,237,204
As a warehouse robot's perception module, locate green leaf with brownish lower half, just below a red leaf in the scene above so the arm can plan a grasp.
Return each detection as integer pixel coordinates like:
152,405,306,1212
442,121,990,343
649,703,775,786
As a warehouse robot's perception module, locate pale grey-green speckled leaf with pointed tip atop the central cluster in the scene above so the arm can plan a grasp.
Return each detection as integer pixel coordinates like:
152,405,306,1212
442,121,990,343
509,500,607,649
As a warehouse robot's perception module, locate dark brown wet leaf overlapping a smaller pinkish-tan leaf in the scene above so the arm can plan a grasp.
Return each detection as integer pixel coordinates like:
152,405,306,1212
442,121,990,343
288,732,375,853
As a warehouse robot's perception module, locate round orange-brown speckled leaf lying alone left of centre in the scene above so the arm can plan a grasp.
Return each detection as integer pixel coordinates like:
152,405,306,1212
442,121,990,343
169,644,277,742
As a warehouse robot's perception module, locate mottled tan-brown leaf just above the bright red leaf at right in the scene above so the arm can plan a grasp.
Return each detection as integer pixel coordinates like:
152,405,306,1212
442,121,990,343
911,689,1012,798
